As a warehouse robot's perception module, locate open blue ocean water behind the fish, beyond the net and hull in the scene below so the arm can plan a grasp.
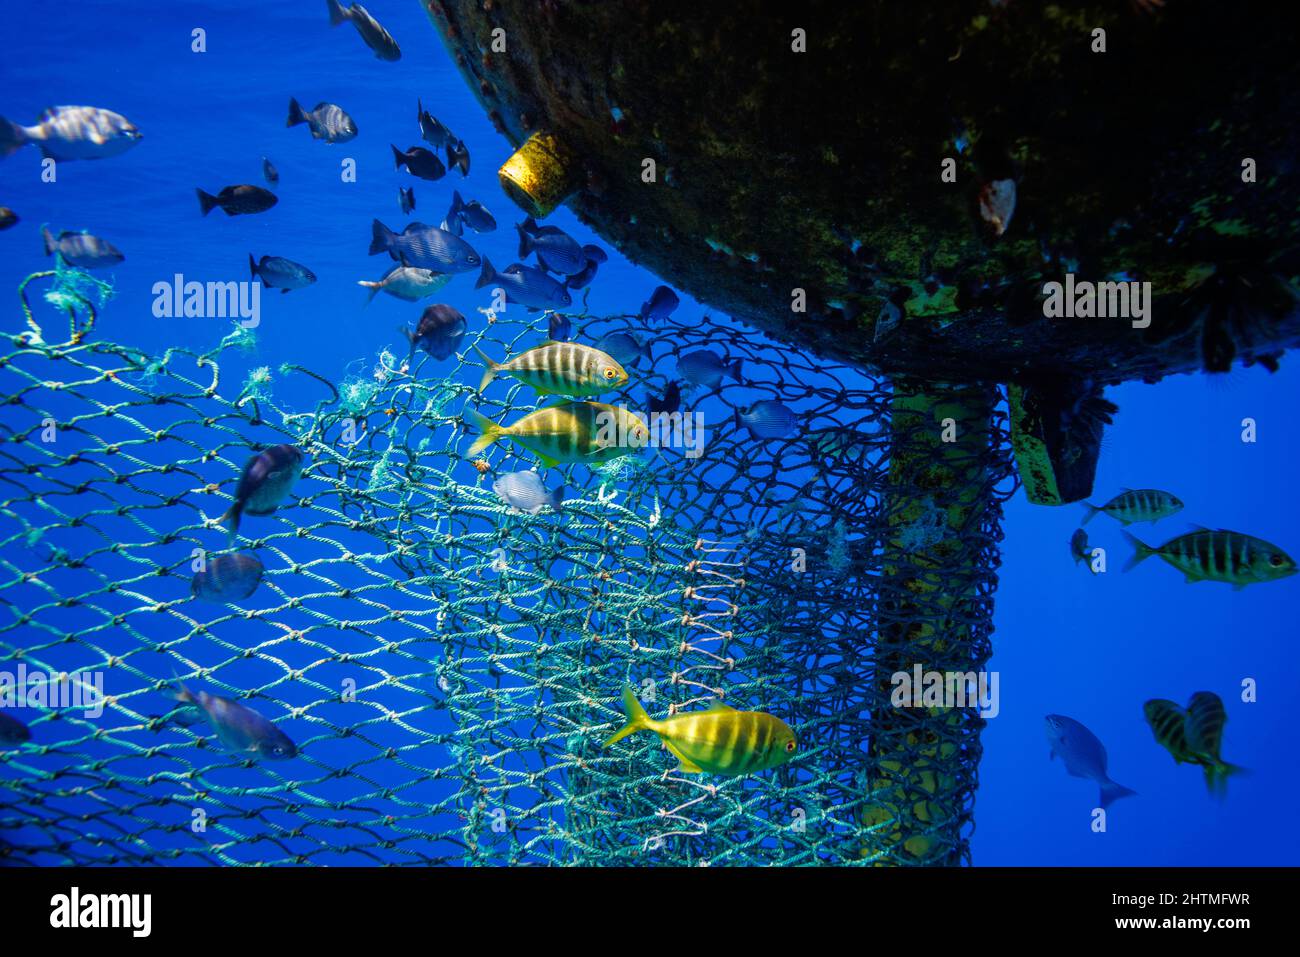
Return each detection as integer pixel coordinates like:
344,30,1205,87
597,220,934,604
0,0,1300,865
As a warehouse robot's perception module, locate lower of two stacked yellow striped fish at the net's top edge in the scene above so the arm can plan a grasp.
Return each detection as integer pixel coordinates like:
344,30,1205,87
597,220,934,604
465,402,650,467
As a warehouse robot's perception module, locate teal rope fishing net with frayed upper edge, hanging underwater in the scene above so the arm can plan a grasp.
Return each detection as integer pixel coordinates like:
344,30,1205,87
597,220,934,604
0,263,1014,865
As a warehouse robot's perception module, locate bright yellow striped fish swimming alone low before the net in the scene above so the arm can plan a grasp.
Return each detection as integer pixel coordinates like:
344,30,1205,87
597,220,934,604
605,688,798,775
